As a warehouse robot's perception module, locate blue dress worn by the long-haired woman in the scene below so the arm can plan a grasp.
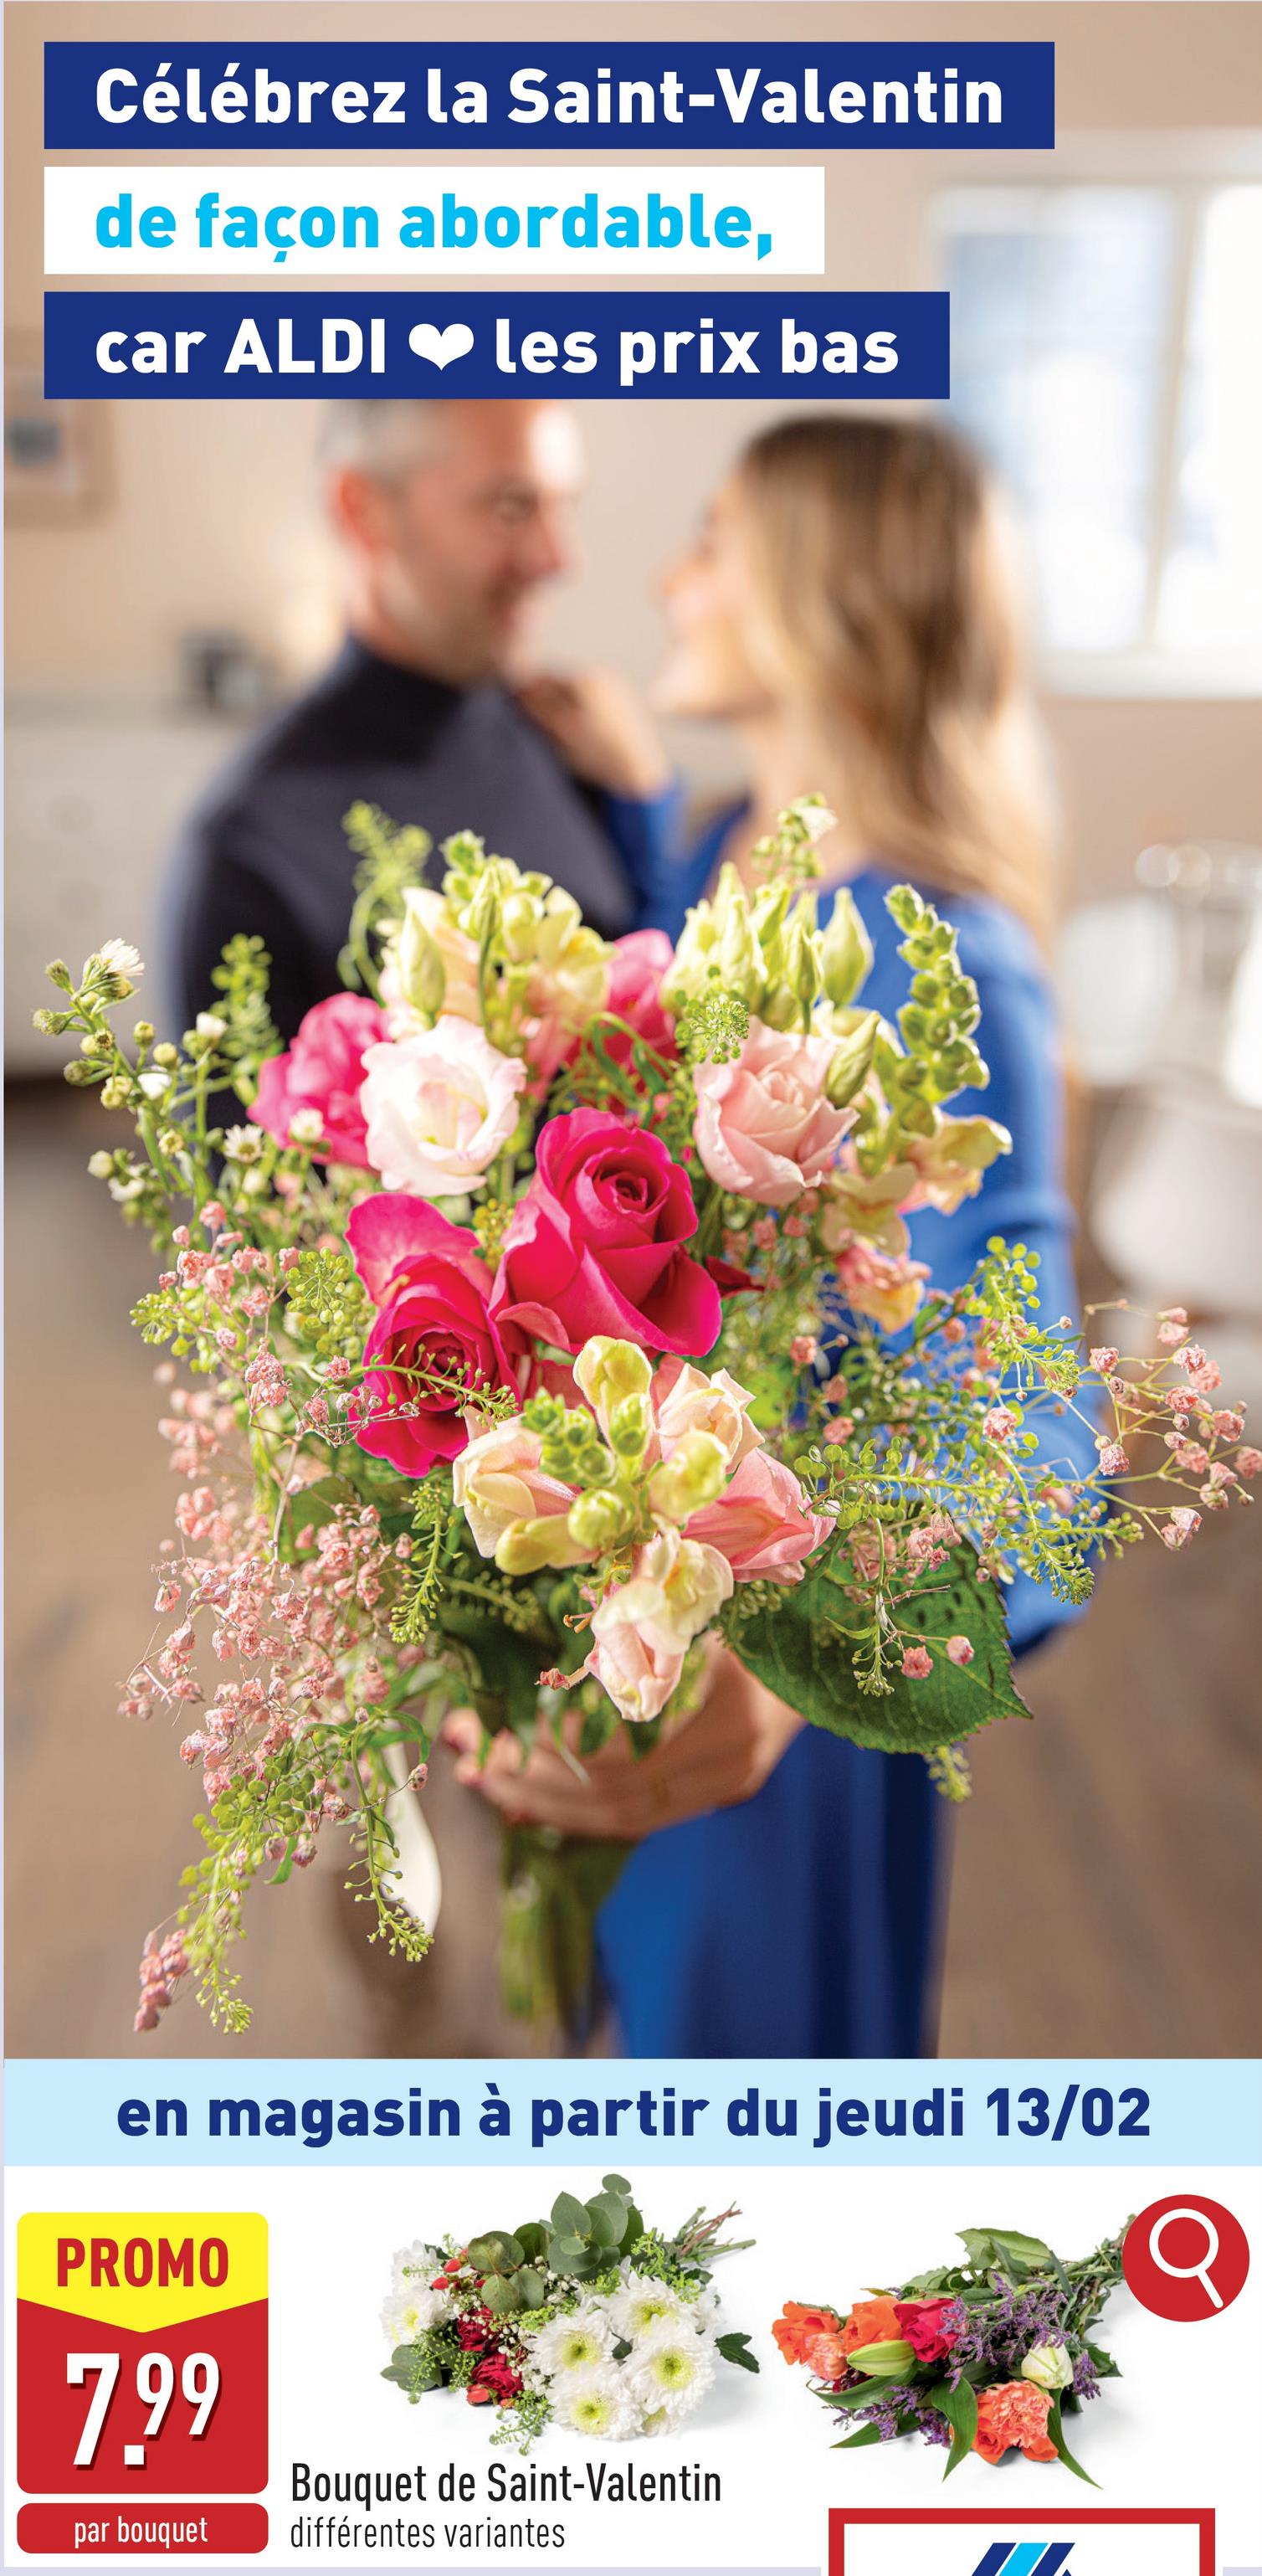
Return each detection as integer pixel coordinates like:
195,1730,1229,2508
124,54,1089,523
587,811,1095,2059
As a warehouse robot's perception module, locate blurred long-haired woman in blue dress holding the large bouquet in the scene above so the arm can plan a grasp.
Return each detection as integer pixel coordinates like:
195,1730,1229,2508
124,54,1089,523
454,417,1090,2059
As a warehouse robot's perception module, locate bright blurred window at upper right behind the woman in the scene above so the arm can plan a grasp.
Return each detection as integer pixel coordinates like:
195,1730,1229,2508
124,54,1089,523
935,180,1262,696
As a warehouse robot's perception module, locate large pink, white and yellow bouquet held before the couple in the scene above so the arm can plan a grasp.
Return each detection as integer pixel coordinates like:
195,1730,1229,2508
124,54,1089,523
36,799,1262,2030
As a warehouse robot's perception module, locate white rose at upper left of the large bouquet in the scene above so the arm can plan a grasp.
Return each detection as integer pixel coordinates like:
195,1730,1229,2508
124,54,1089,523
361,1015,526,1198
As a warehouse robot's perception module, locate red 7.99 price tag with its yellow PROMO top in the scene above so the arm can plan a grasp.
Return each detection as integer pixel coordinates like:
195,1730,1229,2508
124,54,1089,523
18,2210,268,2496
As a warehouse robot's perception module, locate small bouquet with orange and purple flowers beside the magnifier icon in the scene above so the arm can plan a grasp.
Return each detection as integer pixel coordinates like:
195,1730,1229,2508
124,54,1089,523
772,2229,1126,2486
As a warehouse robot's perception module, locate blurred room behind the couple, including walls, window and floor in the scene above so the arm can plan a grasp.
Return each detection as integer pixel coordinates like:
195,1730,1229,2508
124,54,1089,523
5,0,1262,2055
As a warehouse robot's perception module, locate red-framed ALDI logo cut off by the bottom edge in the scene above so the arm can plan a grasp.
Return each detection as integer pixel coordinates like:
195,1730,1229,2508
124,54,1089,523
829,2504,1216,2576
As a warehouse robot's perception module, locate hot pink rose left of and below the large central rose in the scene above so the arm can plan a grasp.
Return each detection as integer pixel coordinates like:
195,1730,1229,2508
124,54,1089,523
345,1190,523,1476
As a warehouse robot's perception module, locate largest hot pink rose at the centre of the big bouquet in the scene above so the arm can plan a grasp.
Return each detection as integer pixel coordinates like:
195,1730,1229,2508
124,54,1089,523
492,1110,721,1355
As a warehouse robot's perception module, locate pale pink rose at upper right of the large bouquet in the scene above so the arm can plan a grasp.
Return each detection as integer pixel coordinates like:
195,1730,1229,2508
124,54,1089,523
693,1020,855,1208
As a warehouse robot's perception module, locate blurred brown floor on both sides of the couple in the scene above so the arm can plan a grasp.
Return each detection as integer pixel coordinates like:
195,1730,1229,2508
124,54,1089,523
5,1090,1262,2055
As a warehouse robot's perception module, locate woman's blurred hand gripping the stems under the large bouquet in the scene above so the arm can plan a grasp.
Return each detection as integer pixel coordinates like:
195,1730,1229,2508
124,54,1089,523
443,1651,803,1842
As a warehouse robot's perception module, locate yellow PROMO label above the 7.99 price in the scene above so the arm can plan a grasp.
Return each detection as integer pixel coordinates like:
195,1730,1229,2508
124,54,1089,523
18,2210,268,2334
